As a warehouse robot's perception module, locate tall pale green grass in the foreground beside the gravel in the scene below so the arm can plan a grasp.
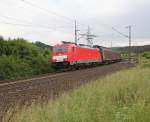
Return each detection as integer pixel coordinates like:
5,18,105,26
4,67,150,122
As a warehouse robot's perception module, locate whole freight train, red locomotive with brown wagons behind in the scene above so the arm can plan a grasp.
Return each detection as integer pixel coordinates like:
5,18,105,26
52,42,121,69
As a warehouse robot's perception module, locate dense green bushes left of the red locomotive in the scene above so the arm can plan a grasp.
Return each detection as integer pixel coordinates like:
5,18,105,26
0,38,52,80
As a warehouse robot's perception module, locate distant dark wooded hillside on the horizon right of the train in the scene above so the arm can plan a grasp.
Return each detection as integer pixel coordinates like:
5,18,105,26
112,45,150,53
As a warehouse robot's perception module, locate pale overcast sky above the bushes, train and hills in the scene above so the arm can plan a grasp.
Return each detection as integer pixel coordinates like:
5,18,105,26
0,0,150,47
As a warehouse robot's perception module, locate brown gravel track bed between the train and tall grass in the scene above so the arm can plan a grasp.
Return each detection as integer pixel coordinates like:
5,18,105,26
0,62,134,118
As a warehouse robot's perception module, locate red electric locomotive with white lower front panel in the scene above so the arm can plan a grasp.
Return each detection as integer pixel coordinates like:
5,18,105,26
52,42,102,68
